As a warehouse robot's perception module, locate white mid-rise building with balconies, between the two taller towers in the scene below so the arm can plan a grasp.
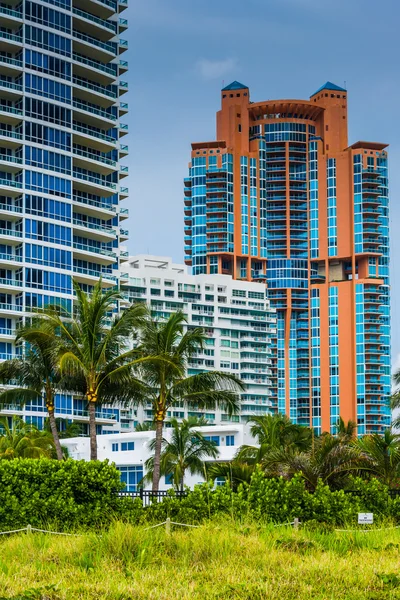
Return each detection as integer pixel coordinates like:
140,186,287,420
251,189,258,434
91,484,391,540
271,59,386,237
114,255,276,433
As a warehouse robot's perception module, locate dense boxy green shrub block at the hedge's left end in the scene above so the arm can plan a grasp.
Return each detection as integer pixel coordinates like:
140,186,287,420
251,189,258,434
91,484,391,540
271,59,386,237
0,459,123,531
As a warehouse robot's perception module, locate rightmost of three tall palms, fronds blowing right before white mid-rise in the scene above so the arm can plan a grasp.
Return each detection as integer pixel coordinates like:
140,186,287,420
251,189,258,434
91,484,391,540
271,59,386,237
141,312,243,492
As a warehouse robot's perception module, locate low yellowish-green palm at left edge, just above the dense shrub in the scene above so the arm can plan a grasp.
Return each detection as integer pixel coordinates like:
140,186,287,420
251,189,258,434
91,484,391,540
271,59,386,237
0,416,55,460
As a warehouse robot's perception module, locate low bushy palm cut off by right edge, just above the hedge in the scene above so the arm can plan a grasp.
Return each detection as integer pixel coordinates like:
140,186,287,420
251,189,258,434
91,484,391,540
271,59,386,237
354,428,400,486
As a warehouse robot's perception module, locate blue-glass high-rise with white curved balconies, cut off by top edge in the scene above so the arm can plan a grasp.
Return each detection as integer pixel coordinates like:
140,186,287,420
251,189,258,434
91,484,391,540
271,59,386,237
0,0,128,427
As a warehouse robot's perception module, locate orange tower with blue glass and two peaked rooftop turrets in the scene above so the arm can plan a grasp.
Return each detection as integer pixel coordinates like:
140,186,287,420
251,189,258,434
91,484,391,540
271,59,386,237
184,81,390,434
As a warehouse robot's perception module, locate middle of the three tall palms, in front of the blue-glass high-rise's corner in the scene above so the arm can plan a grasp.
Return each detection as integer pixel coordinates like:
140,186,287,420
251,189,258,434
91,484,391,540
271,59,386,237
38,280,151,460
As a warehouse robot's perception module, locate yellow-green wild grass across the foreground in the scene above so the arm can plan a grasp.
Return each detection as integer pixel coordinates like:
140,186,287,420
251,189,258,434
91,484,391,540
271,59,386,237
0,522,400,600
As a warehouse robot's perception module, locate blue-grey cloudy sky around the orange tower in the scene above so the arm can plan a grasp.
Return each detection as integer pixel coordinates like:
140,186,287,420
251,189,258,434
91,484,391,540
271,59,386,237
121,0,400,368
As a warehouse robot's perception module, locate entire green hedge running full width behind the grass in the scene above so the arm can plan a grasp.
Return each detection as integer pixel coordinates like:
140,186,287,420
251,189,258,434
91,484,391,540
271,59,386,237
0,459,400,531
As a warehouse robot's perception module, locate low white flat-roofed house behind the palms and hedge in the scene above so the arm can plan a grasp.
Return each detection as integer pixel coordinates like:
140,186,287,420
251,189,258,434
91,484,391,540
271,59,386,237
62,423,254,492
